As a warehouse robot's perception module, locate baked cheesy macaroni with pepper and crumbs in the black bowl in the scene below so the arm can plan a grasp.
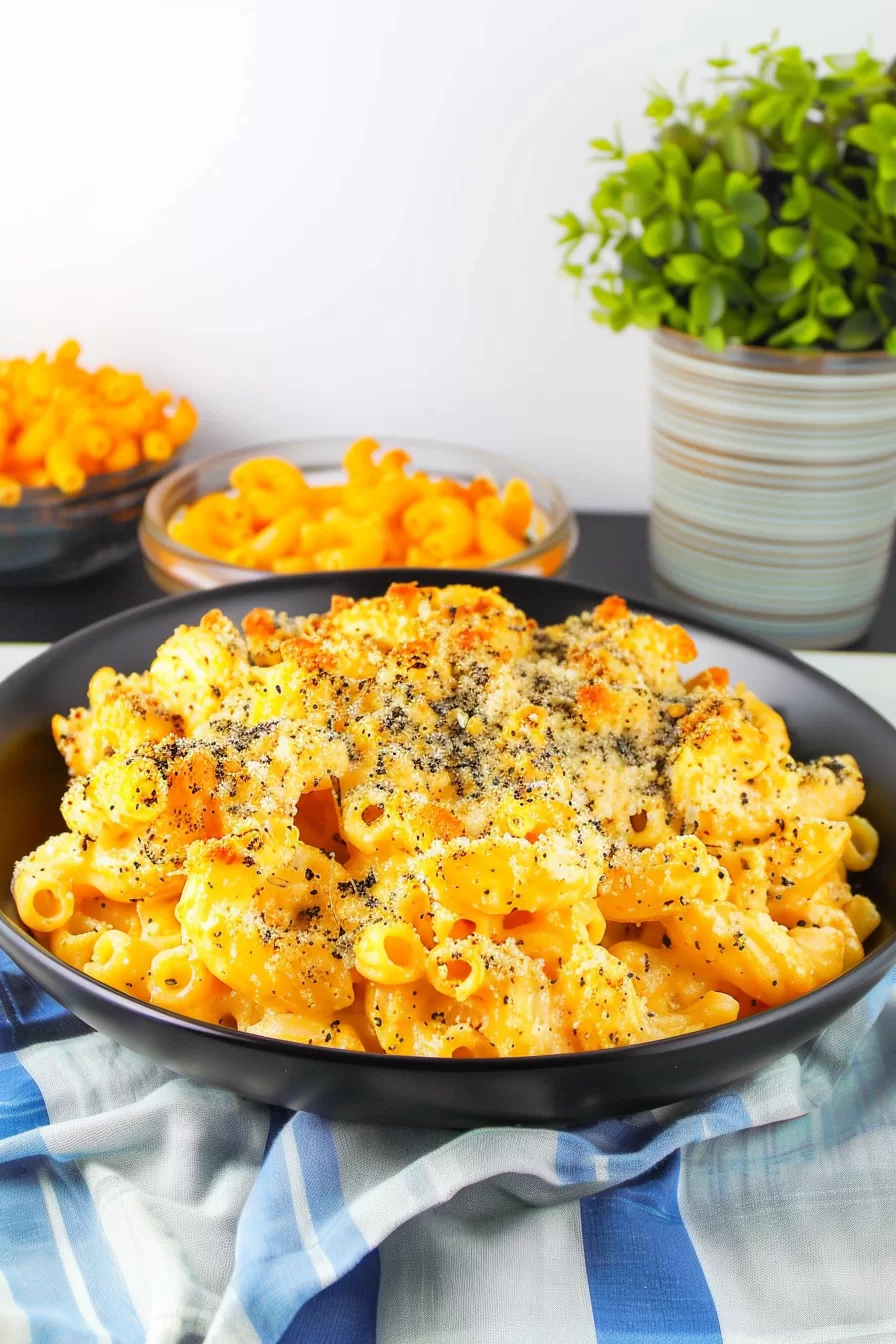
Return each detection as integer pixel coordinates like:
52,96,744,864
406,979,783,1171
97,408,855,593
13,588,880,1058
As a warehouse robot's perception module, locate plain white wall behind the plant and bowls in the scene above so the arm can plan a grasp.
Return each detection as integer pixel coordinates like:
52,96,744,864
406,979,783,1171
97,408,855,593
0,0,896,509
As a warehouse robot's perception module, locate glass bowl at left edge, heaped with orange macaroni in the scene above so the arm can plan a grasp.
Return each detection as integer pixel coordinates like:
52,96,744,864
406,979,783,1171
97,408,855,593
0,462,178,587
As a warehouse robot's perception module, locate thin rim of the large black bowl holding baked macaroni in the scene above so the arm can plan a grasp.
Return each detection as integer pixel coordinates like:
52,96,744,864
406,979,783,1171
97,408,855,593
0,566,896,1073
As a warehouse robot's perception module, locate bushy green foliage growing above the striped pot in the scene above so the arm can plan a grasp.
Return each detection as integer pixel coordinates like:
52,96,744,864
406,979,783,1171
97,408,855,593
556,36,896,355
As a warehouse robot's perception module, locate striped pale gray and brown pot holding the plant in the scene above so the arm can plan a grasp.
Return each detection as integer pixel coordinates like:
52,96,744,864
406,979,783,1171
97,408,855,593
650,329,896,649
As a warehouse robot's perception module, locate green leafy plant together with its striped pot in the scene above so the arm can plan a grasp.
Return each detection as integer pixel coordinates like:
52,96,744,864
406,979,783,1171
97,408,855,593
557,39,896,648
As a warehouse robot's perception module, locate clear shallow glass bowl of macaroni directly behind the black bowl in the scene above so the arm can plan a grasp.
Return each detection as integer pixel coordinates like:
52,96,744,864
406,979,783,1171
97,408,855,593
140,435,579,593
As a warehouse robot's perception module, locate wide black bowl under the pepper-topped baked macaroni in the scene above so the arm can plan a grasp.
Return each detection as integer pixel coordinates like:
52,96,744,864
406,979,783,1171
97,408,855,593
0,570,896,1129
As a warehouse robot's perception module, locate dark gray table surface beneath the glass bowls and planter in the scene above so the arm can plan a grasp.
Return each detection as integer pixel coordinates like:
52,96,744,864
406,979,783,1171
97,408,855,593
0,513,896,653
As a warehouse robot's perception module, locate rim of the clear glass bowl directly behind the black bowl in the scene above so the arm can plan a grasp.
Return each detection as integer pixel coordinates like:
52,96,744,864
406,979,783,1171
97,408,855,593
140,434,578,575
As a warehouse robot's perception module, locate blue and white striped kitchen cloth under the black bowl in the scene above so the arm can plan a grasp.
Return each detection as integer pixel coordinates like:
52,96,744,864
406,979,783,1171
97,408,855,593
0,953,896,1344
